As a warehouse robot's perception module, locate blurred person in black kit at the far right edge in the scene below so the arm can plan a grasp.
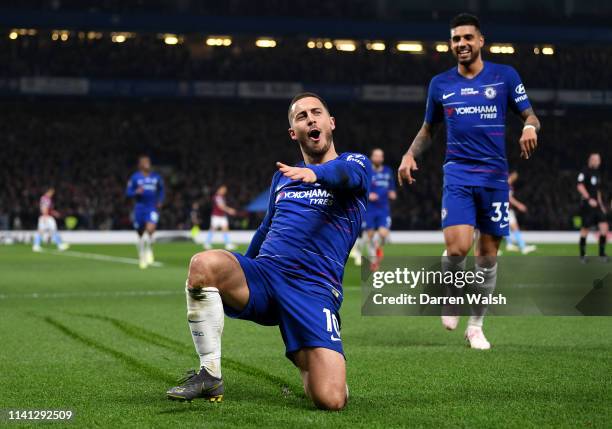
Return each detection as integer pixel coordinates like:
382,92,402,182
576,153,609,262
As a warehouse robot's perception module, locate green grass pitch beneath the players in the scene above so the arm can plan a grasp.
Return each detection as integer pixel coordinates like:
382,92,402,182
0,243,612,428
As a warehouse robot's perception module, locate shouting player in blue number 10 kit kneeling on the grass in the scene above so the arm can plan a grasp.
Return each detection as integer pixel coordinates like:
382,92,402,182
167,93,372,410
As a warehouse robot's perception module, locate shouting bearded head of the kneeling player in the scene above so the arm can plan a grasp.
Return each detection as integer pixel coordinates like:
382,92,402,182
289,97,336,157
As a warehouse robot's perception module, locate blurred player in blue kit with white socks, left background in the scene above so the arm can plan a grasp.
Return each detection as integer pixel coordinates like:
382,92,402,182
125,155,164,269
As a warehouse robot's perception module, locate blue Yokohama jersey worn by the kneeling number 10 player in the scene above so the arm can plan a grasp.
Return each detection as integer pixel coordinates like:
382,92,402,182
246,153,372,297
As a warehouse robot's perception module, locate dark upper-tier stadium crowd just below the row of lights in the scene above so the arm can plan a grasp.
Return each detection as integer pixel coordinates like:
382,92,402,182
0,34,612,89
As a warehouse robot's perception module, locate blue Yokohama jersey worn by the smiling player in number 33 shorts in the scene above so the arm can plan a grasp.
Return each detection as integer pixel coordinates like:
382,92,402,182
425,61,531,189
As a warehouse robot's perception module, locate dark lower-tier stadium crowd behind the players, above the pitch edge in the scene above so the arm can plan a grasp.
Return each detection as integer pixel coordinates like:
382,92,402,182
0,100,612,230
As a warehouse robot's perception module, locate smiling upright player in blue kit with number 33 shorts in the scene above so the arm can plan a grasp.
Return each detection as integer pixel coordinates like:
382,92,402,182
398,14,540,349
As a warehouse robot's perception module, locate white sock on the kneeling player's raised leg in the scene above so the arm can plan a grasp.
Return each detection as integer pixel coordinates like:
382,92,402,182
185,287,224,378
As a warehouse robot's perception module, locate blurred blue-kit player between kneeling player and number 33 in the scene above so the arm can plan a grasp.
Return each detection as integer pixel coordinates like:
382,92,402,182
366,148,397,271
